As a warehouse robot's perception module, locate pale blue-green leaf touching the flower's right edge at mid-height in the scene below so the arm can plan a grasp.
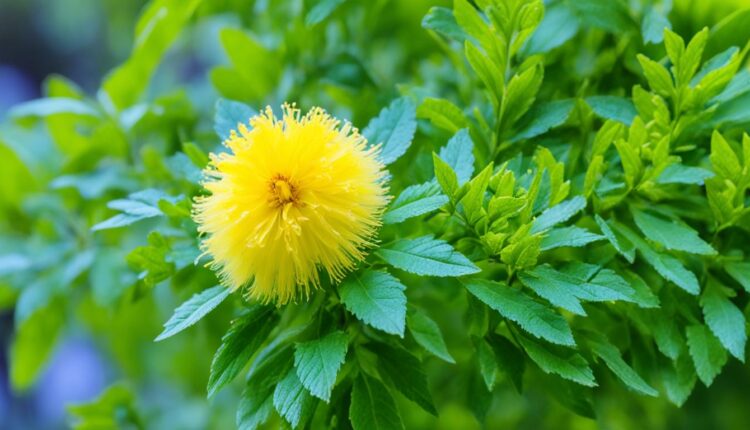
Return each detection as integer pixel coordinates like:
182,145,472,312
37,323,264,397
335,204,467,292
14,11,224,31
383,182,448,224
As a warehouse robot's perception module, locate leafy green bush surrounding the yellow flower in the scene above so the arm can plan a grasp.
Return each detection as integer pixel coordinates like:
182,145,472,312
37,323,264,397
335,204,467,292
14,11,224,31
0,0,750,429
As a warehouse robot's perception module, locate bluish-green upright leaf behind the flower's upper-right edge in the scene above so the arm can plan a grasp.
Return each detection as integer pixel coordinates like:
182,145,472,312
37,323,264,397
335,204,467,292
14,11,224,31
362,98,417,164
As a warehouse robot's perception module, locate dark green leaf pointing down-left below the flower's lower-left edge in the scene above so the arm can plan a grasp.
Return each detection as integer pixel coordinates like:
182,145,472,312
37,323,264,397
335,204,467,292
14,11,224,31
208,306,278,397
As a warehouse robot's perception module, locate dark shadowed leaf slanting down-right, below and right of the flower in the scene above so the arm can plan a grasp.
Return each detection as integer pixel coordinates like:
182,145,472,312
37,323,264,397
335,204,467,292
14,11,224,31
368,342,437,416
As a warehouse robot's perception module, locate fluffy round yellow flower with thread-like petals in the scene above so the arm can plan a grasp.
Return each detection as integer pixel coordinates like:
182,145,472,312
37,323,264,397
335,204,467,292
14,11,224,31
193,105,388,304
